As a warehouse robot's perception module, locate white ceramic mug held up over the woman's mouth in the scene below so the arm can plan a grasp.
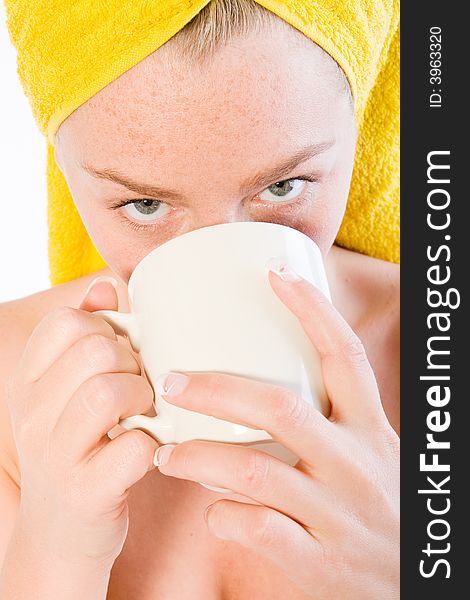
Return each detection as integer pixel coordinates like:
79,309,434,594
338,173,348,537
94,221,330,492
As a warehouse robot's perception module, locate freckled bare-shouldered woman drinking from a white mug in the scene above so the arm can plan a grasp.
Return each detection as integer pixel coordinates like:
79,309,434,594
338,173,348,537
0,0,399,600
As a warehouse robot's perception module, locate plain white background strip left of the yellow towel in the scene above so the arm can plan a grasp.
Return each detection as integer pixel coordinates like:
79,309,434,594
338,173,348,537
0,2,51,302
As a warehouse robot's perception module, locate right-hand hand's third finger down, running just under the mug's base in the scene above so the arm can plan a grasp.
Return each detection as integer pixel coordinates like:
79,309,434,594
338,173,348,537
157,440,332,528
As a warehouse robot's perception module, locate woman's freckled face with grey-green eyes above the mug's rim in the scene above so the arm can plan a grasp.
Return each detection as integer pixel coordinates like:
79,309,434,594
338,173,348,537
55,28,356,283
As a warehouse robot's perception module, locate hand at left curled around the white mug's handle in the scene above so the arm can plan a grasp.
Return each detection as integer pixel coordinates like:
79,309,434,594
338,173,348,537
7,282,158,569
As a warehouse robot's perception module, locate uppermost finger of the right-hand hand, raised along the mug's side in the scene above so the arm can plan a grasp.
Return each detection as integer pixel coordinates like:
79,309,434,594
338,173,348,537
269,273,383,422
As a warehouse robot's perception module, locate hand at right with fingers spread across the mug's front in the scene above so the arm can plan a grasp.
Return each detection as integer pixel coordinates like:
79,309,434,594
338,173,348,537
152,262,399,600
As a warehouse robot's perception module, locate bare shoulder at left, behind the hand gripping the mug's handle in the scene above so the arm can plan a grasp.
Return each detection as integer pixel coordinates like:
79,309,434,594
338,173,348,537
0,269,110,484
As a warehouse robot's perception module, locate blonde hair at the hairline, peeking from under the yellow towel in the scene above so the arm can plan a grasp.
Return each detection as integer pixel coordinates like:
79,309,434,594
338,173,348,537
170,0,353,106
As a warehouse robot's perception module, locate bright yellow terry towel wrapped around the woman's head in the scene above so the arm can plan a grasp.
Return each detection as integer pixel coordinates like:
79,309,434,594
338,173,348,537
5,0,399,285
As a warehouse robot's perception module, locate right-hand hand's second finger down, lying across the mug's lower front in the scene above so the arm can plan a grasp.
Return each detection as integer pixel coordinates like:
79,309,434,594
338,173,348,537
156,372,341,466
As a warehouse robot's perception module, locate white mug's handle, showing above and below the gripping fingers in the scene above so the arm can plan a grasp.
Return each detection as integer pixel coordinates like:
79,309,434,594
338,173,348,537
91,310,172,444
